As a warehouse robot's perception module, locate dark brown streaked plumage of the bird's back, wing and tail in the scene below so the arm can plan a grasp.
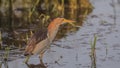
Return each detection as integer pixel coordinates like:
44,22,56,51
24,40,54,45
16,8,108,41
25,29,48,55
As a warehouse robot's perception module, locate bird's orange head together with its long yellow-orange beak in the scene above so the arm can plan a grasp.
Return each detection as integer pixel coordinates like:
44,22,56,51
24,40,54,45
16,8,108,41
53,18,75,26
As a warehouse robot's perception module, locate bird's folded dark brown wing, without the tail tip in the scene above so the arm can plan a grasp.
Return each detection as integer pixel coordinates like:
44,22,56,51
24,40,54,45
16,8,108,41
27,29,47,48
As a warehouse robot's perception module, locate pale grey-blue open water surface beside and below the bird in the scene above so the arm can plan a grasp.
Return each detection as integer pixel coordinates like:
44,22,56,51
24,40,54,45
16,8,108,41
2,0,120,68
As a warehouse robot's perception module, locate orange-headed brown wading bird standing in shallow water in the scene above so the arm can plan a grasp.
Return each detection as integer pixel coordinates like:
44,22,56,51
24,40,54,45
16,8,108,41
24,18,75,64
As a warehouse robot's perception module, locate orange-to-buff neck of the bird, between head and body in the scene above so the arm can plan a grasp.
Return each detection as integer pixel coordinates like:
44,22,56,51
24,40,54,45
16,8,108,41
48,22,59,42
